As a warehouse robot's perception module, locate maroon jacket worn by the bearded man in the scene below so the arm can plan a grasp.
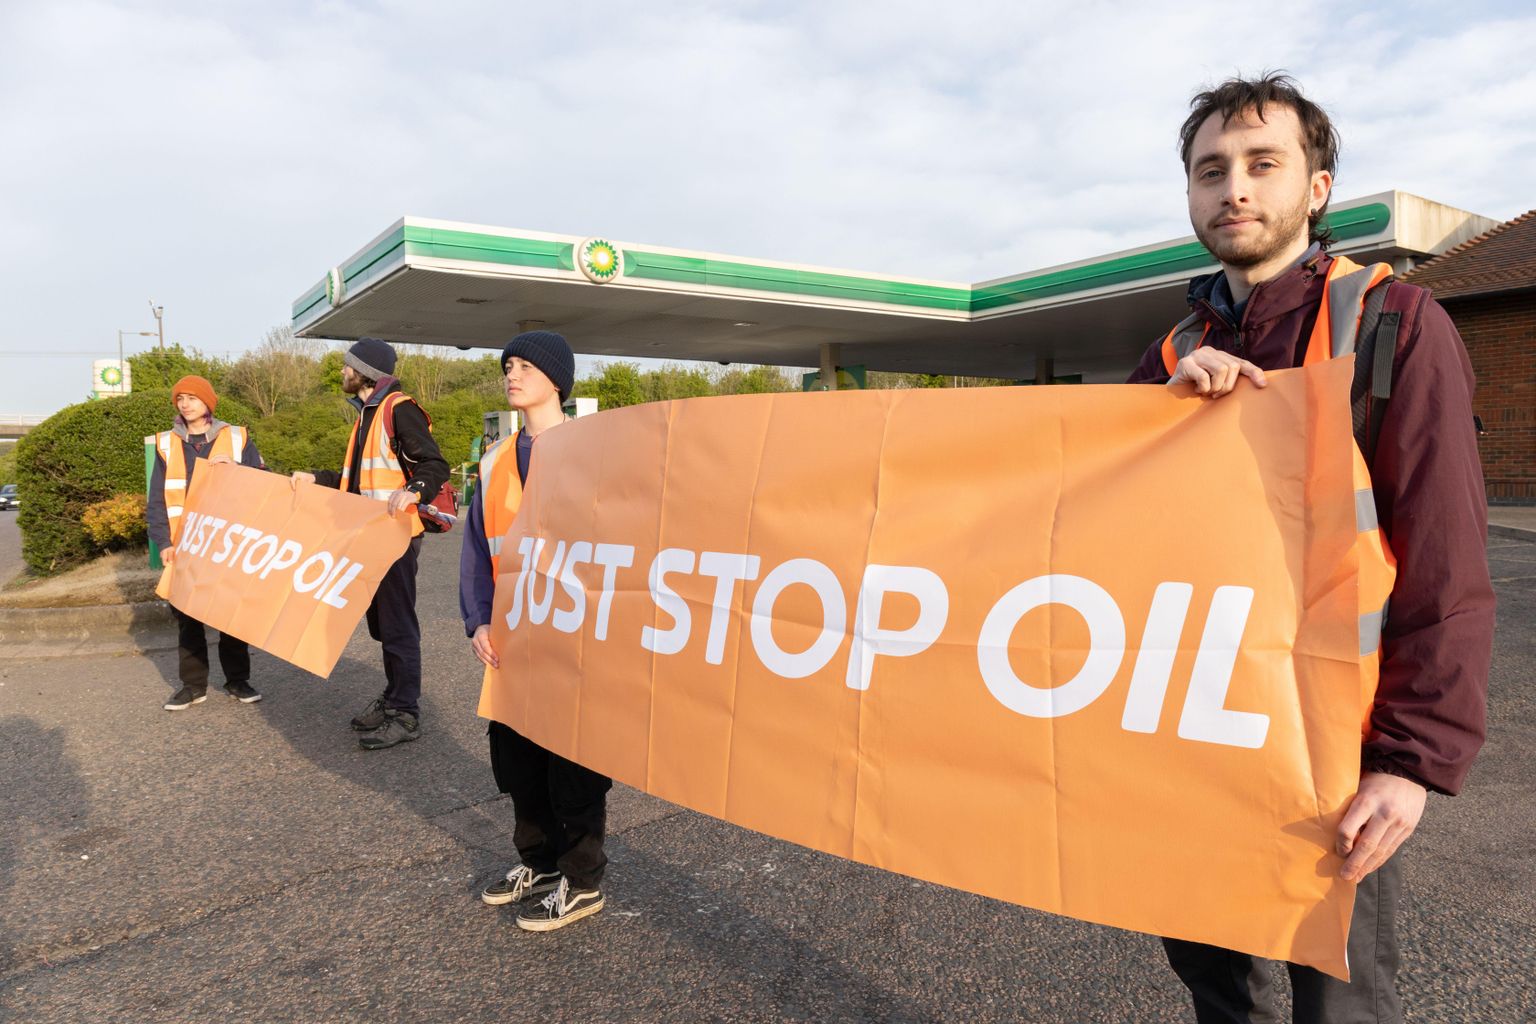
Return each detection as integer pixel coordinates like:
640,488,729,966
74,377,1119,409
1129,252,1493,794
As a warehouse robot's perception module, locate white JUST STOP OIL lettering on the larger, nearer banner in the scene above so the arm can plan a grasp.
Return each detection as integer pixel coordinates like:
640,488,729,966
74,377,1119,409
497,540,1269,749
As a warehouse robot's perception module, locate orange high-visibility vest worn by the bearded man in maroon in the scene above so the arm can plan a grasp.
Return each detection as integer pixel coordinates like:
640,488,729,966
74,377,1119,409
1163,256,1398,737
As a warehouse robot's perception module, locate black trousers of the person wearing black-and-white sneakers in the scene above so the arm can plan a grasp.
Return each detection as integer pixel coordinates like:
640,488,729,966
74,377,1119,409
488,722,613,889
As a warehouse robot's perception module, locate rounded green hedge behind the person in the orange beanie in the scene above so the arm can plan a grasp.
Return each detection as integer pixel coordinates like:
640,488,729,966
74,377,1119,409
15,390,260,576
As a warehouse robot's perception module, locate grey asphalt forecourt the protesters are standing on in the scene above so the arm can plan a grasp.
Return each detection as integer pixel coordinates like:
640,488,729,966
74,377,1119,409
0,525,1536,1024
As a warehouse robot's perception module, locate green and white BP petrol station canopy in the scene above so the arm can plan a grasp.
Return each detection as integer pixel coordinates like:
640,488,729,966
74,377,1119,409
293,192,1496,382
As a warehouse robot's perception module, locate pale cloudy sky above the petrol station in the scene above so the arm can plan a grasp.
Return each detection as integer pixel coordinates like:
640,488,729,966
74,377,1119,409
0,0,1536,416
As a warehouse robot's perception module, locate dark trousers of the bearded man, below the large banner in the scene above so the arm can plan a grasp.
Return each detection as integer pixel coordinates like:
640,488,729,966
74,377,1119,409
1163,855,1402,1024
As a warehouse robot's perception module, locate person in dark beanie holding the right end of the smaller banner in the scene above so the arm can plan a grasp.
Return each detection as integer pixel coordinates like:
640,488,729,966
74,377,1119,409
293,338,450,751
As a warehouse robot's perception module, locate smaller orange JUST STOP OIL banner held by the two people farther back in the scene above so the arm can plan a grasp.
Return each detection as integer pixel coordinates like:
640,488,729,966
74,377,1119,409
155,462,410,676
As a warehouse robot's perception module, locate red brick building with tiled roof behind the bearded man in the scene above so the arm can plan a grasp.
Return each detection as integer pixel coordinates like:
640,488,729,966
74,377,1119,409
1404,210,1536,505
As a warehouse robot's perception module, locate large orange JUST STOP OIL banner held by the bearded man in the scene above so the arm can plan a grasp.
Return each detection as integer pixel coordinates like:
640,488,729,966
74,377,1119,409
481,359,1364,976
